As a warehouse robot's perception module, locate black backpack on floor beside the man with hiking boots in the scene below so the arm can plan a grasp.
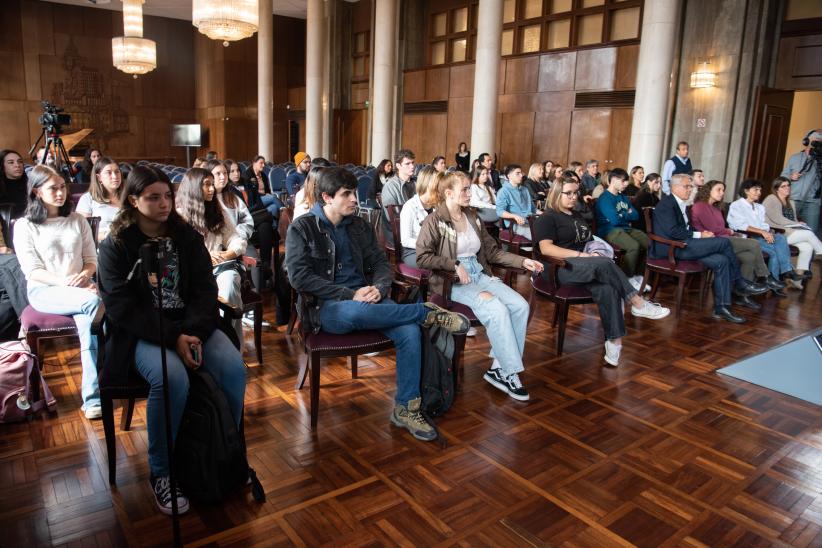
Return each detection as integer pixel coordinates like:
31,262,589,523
420,326,456,417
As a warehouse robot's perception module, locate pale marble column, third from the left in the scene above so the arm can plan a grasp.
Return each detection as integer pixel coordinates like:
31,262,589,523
370,0,399,165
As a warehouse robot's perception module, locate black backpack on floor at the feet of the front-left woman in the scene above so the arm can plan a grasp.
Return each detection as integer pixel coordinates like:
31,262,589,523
174,369,265,503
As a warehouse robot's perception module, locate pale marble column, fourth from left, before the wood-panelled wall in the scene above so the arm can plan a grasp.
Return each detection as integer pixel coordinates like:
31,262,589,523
468,0,503,165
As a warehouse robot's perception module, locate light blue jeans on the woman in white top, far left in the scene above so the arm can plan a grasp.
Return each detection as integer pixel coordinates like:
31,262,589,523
28,285,102,409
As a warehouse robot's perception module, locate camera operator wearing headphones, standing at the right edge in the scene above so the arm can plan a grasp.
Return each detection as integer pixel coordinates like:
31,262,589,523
782,129,822,234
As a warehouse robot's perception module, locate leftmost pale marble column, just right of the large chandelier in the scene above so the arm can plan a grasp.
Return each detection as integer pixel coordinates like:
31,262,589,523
257,0,278,158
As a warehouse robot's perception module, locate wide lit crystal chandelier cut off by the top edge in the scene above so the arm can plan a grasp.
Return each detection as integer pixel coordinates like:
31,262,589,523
191,0,260,47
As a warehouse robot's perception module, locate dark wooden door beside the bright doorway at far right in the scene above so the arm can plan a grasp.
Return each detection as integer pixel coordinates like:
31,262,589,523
742,87,793,185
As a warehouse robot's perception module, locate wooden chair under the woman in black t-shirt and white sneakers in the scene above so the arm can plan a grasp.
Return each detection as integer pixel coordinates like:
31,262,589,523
528,225,594,356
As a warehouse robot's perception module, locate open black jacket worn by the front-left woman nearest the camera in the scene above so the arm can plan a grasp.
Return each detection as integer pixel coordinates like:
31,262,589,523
97,224,217,386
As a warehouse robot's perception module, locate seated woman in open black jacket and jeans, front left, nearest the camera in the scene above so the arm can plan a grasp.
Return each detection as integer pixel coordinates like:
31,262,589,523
98,166,245,514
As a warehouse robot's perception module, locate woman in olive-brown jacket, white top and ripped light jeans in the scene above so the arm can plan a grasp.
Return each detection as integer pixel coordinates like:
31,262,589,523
417,171,542,401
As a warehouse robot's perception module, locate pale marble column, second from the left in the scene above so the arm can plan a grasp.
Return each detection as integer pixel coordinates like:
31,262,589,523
305,0,325,158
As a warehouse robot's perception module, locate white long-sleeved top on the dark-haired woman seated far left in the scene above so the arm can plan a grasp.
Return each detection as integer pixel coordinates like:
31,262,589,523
14,211,97,287
